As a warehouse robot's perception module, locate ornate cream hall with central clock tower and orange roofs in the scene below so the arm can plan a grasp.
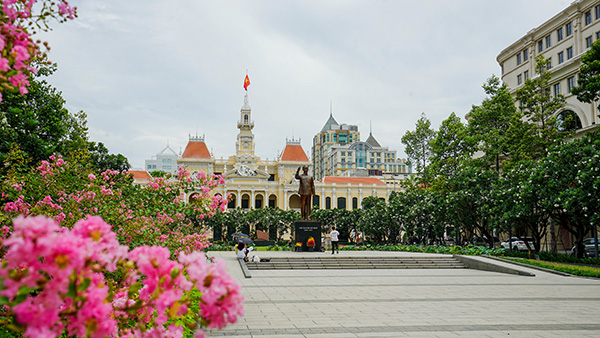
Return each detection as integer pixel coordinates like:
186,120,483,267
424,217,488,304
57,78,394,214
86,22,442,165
177,94,394,210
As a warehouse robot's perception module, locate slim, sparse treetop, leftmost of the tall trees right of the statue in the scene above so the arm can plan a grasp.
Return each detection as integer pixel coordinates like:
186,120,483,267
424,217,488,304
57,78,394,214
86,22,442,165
402,113,435,176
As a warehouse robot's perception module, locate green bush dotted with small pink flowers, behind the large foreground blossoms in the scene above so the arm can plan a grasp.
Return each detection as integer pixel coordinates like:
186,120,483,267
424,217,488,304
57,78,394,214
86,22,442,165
0,156,227,257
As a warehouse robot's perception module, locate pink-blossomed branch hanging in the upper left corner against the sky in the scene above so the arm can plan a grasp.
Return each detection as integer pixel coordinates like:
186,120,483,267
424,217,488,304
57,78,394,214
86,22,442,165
0,0,77,101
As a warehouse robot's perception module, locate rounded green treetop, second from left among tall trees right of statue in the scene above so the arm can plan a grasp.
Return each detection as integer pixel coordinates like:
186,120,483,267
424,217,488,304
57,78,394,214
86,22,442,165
429,113,473,178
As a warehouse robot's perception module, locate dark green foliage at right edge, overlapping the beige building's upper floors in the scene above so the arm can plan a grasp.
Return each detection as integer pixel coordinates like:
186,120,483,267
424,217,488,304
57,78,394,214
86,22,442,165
571,40,600,103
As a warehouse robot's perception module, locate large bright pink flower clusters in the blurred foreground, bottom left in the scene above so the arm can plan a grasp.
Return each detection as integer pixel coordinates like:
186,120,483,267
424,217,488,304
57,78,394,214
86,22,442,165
0,216,244,337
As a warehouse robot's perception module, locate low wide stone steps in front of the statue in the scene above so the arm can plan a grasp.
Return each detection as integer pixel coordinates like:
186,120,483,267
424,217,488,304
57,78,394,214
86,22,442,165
246,256,467,270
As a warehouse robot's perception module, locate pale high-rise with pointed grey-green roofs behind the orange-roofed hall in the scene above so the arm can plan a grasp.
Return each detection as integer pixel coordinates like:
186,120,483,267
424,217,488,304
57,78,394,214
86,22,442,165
312,113,412,183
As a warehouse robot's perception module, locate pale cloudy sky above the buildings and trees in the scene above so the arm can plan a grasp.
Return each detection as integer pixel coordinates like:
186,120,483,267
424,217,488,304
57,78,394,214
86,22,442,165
41,0,571,169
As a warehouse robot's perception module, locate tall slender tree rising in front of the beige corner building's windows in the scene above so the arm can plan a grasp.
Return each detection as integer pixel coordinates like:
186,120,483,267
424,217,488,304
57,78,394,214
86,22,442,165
515,54,569,159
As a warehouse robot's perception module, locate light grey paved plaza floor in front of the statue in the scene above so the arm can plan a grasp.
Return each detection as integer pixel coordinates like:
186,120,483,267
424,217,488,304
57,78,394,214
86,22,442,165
210,251,600,338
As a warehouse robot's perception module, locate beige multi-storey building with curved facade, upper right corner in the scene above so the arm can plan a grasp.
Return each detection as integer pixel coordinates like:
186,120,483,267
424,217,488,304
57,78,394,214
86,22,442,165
497,0,600,135
